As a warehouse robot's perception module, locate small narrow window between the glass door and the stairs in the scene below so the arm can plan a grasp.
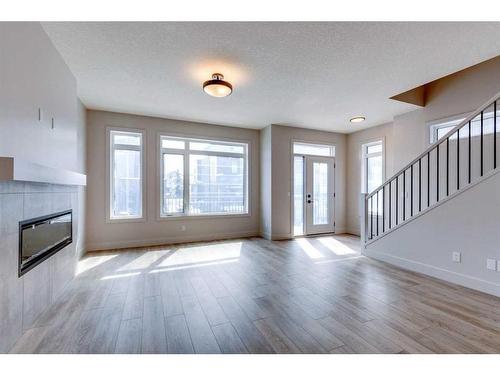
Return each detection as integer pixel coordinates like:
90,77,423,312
361,140,384,194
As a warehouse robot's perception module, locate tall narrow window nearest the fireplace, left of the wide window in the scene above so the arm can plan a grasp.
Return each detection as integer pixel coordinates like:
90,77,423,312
110,130,143,219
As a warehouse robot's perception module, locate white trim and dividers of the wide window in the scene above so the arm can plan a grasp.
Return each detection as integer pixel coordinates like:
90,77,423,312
155,132,252,221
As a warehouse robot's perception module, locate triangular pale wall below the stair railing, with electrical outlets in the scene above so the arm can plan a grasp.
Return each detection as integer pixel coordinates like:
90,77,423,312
363,169,500,296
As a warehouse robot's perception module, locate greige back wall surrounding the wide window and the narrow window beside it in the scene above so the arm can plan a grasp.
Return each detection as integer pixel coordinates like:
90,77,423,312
86,111,260,250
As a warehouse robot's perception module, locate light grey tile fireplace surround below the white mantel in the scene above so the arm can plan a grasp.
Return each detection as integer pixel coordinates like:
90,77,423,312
0,181,84,353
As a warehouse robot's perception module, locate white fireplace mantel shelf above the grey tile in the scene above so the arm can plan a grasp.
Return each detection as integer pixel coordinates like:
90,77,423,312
0,157,87,186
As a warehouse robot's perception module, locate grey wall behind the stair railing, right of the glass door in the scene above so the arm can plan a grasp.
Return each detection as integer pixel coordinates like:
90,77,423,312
347,57,500,234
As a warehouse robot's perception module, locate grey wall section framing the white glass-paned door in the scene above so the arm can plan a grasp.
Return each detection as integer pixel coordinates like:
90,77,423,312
261,125,347,239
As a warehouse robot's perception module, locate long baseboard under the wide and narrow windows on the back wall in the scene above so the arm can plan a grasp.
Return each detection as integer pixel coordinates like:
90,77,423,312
86,231,260,251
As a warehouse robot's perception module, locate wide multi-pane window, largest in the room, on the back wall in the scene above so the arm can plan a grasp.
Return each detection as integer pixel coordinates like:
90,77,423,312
160,136,248,217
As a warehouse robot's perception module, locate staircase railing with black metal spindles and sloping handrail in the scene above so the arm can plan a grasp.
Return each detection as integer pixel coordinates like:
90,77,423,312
361,93,500,246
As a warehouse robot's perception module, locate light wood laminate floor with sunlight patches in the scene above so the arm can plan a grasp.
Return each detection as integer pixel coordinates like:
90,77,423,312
12,235,500,353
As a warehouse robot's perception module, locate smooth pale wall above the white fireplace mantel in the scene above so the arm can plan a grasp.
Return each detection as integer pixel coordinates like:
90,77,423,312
0,22,79,171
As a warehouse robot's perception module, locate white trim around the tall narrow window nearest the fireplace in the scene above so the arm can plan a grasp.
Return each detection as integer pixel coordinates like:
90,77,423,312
105,126,147,224
